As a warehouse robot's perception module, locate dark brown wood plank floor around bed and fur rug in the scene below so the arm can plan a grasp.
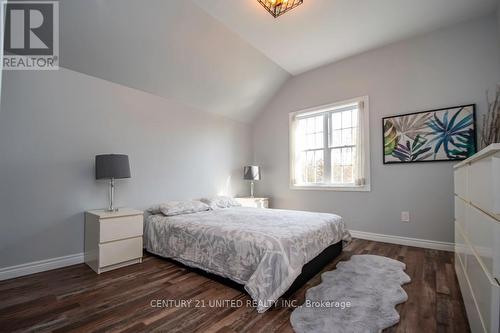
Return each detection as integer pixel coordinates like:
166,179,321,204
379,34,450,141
0,239,469,333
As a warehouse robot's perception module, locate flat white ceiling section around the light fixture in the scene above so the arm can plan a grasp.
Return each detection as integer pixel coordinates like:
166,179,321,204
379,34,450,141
193,0,498,75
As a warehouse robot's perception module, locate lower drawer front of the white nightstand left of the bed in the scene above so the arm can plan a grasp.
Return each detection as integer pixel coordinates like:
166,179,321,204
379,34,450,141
99,237,142,267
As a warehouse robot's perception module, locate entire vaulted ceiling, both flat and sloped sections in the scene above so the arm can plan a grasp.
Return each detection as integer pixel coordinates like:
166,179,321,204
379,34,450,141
60,0,497,121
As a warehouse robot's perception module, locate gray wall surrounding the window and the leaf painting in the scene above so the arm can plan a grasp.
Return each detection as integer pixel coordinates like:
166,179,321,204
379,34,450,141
253,16,500,241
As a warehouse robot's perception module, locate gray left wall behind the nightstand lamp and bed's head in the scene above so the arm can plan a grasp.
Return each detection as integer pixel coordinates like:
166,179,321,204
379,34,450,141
0,69,252,267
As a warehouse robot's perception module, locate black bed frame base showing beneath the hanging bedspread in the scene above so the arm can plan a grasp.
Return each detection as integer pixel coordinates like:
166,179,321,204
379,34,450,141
158,241,342,298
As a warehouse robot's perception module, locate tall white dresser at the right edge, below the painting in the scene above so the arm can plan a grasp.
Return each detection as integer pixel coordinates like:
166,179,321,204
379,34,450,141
454,144,500,333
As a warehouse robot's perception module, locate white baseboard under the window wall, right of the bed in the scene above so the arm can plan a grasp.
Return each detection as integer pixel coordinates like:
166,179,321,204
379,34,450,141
349,230,455,252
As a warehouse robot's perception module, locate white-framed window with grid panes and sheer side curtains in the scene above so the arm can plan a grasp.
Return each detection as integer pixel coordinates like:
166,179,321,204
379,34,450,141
290,97,370,191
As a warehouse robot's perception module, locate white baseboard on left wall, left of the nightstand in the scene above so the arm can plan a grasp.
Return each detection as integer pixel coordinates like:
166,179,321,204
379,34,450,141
0,253,84,281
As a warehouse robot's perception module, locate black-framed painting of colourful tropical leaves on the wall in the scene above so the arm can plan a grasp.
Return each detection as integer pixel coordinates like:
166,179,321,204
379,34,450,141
383,105,476,163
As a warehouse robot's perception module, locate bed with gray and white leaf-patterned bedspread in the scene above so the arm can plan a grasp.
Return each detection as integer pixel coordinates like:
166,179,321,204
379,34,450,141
144,207,350,313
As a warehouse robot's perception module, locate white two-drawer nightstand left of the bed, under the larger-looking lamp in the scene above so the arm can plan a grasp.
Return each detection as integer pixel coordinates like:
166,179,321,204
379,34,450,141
85,208,144,274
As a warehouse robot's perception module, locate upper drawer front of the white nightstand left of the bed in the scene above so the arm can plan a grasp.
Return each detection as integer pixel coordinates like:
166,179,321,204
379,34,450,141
99,215,143,243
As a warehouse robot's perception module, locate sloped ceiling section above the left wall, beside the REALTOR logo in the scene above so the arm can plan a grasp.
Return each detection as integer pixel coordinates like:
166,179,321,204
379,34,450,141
60,0,289,121
